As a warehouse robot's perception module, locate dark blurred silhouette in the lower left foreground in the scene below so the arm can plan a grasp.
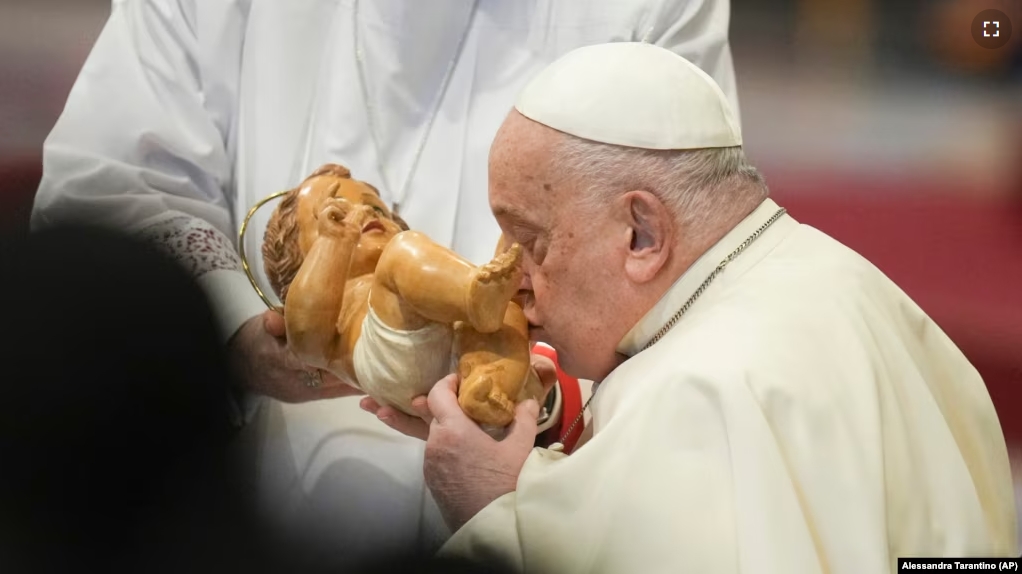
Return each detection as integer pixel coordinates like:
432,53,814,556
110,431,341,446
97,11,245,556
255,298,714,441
0,227,510,573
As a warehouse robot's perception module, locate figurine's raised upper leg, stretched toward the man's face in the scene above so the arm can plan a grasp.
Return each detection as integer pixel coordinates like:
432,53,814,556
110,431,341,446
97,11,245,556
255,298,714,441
371,231,521,333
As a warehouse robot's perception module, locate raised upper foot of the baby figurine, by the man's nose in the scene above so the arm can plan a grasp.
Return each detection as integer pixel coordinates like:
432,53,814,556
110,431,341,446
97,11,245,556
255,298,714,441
467,243,522,333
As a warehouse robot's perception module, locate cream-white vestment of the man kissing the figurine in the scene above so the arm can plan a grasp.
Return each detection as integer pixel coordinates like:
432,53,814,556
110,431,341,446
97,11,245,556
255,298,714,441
442,195,1019,574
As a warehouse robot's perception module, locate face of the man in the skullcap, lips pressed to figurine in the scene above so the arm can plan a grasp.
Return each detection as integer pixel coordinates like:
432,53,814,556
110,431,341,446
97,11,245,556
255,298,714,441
490,113,623,380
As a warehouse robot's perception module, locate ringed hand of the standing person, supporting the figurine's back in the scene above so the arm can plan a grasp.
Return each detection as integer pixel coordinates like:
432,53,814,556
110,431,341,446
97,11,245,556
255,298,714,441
228,310,364,402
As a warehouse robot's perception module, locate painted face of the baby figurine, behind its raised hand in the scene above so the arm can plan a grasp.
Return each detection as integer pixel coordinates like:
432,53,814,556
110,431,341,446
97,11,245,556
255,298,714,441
297,175,402,276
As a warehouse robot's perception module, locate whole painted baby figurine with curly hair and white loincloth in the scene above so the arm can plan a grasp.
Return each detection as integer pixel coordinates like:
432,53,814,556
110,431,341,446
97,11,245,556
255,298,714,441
263,164,544,430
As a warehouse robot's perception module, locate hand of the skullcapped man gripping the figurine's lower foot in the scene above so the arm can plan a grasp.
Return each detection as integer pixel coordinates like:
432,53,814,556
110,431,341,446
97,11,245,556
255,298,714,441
423,375,540,531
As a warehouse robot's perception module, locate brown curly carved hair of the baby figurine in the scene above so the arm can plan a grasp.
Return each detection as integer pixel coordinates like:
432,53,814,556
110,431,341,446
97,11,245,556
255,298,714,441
263,163,408,303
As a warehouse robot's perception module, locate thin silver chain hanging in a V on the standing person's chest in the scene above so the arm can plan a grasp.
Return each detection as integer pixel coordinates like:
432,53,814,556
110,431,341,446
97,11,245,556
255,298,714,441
352,0,479,214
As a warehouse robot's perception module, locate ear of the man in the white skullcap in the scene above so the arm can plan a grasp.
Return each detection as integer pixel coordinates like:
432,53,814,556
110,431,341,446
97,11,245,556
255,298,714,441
623,190,675,283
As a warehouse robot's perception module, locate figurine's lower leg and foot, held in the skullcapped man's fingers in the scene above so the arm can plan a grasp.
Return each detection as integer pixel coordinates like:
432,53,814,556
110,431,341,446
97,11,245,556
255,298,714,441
456,302,543,427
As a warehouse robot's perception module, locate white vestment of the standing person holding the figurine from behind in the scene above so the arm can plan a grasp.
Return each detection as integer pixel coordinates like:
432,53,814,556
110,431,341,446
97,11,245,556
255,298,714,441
33,0,737,557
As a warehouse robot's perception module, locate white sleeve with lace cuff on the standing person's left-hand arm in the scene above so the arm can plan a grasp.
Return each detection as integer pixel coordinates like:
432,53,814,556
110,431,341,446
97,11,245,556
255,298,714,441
32,0,266,336
